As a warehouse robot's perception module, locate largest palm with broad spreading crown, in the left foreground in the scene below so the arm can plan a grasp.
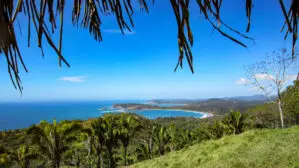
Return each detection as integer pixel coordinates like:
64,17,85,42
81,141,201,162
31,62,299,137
27,120,81,168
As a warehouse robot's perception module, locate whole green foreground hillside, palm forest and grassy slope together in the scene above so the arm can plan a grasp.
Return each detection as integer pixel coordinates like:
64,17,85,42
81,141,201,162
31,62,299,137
0,81,299,168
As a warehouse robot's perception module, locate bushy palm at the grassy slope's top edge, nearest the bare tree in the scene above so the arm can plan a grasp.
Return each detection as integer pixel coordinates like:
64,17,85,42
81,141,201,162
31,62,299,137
223,110,250,134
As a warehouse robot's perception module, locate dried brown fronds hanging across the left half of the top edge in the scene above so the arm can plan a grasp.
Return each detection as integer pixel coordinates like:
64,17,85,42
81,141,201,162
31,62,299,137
0,0,148,93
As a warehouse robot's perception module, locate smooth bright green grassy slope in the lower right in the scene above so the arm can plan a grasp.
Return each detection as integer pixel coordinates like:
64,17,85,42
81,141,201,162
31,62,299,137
131,126,299,168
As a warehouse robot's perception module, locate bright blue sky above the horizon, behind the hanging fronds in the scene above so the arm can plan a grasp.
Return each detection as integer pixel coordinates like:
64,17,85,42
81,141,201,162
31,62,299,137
0,0,291,101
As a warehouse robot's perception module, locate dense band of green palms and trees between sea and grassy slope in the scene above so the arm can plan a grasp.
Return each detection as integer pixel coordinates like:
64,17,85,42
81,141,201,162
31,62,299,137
0,105,298,168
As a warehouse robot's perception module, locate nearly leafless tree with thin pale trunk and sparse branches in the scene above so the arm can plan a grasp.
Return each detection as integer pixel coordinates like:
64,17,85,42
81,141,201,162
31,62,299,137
246,49,298,127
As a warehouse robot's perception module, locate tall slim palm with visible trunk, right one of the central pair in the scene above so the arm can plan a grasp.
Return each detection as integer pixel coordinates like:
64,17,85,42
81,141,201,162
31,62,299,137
119,114,139,166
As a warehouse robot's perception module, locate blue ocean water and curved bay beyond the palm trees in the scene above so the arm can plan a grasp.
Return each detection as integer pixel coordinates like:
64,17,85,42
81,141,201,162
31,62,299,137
0,101,203,130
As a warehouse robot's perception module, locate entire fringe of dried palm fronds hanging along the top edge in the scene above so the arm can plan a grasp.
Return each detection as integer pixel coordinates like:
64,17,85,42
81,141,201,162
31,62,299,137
0,0,299,93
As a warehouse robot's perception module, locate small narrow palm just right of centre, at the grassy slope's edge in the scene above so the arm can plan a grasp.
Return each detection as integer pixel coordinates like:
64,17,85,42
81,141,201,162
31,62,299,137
154,126,170,156
